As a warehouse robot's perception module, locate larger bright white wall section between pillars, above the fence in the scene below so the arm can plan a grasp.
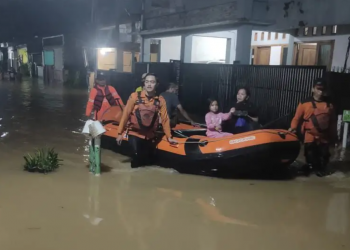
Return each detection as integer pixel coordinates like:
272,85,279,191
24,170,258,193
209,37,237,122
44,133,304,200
191,36,227,62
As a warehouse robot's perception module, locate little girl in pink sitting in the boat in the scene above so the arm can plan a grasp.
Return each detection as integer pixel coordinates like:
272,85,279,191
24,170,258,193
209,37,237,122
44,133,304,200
205,99,235,138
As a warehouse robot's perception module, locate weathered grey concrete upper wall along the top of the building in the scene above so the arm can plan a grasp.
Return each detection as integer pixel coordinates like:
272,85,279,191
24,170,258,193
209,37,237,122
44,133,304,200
145,0,350,31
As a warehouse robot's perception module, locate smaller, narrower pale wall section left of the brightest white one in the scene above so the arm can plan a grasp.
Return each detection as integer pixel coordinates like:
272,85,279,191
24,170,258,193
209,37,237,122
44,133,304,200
157,36,181,62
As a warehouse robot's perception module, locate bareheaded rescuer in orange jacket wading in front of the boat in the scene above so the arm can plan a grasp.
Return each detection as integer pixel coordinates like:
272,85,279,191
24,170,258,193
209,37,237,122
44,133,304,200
117,73,177,168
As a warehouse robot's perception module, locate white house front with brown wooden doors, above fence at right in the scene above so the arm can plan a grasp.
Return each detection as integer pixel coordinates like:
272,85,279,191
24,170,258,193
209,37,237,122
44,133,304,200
251,25,350,72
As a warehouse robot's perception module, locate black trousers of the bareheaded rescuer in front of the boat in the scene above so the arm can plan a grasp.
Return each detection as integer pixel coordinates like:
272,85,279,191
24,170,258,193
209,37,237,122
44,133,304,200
128,135,156,168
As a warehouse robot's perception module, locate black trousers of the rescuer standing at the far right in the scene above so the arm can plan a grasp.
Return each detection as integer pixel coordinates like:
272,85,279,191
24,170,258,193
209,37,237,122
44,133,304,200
304,142,330,171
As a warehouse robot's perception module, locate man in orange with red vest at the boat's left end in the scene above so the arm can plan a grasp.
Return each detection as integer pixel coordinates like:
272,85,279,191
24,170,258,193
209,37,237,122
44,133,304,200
85,72,124,120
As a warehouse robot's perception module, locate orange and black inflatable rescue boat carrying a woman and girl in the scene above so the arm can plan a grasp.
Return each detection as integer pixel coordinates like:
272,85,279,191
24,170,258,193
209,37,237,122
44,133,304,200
102,106,300,174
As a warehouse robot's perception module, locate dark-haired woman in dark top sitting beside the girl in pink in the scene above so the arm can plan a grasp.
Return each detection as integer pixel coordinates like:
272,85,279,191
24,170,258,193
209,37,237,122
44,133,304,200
230,88,259,134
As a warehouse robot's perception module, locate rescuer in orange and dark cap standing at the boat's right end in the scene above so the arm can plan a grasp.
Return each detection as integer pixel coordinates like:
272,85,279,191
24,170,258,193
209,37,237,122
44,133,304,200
289,79,336,177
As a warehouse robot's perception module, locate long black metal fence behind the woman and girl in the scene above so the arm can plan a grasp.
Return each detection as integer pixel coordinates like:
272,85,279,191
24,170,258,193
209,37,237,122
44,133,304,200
136,63,326,127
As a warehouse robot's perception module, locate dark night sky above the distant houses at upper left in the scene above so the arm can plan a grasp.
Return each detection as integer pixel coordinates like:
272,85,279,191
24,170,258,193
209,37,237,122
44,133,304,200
0,0,105,42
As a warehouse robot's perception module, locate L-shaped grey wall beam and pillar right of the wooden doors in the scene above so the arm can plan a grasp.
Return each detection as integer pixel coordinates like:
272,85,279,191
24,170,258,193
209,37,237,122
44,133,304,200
294,35,350,68
